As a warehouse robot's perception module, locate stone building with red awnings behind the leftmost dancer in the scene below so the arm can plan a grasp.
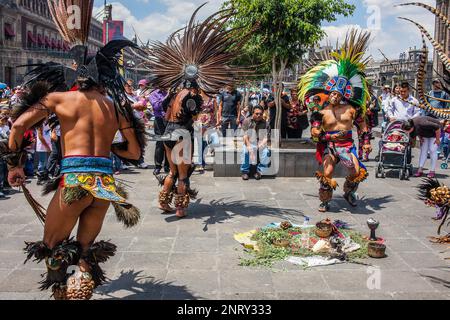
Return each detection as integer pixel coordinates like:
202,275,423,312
0,0,103,86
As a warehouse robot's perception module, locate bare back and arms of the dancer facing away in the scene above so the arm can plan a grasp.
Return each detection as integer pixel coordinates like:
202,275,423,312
8,90,141,186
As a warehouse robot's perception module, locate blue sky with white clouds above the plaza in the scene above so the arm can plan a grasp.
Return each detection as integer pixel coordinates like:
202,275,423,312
95,0,435,60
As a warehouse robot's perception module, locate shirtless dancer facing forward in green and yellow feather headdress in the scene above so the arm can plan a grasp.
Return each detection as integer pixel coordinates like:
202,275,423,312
300,31,371,212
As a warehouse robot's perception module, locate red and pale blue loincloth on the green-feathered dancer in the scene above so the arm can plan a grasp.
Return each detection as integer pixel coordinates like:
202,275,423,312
318,131,367,171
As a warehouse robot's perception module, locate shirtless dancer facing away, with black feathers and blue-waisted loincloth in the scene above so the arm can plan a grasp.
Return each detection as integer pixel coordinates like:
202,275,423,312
2,2,142,299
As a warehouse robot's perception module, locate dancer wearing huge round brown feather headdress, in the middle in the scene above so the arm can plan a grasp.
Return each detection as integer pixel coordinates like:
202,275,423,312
148,5,251,218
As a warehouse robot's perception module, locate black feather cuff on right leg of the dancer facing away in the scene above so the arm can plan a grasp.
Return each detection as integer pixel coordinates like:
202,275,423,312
82,241,117,287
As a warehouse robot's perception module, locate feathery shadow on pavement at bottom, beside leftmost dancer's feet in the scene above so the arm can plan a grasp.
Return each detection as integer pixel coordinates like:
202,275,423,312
97,270,200,300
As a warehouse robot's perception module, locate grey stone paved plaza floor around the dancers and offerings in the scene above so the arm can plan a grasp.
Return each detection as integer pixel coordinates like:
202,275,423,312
0,140,450,300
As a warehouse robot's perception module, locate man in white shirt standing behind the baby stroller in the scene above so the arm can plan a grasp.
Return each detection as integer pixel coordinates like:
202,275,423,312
386,82,421,122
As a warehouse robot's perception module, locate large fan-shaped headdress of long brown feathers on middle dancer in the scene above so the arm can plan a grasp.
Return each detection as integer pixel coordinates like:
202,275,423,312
147,4,248,94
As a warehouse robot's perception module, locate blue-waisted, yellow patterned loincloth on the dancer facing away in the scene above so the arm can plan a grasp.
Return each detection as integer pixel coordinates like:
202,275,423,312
60,156,127,204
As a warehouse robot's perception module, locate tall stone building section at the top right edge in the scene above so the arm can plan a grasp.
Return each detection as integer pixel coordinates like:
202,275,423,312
433,0,450,77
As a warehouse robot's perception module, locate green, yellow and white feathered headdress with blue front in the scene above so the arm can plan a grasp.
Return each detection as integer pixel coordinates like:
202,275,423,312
299,29,370,113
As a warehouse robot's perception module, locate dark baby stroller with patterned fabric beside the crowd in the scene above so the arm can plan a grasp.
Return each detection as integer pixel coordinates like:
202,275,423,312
375,121,412,180
